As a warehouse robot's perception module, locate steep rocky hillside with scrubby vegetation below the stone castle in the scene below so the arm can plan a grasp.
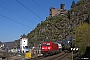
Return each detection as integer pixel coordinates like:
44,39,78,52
27,0,90,44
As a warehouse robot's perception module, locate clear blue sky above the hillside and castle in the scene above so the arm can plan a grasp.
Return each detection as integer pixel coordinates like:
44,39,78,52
0,0,78,42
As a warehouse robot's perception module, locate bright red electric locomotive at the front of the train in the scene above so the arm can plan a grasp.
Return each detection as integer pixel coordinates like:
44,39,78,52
41,42,59,55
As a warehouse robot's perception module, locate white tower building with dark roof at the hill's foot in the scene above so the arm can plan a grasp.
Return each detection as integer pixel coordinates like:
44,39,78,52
20,34,28,53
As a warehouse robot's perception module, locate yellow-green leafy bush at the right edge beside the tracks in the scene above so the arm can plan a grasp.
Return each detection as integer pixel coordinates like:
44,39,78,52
76,23,90,54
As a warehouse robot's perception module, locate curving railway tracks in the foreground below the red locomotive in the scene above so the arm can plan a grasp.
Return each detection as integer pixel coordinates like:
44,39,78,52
30,52,69,60
